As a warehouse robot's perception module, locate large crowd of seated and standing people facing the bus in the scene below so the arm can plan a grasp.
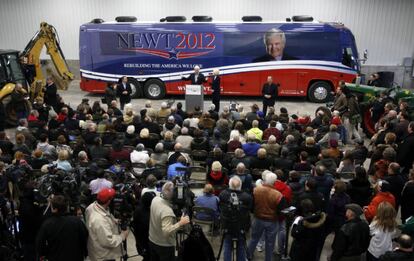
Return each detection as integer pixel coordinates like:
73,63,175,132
0,79,414,261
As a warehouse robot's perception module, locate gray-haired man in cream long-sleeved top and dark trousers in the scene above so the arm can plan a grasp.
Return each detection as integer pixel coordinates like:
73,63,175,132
149,181,190,261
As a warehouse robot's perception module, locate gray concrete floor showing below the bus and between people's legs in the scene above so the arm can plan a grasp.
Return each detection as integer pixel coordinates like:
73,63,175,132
47,81,340,261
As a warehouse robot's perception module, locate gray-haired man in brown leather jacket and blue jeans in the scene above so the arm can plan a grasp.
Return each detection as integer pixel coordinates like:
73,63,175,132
248,172,287,261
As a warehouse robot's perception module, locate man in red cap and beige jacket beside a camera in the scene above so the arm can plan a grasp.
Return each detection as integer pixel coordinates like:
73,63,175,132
85,188,128,261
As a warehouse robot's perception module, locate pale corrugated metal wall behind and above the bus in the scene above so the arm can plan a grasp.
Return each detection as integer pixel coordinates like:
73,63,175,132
0,0,414,65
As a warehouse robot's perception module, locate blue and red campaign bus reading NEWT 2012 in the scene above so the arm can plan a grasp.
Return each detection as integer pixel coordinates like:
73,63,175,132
79,15,360,102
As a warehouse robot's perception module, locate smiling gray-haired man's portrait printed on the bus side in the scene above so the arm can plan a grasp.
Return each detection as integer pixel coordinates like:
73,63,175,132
253,28,296,63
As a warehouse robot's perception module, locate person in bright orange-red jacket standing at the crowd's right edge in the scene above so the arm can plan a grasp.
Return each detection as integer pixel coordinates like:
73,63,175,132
364,180,395,222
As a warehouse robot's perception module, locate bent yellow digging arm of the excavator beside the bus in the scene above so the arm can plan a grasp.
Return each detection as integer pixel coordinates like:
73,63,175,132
21,22,74,93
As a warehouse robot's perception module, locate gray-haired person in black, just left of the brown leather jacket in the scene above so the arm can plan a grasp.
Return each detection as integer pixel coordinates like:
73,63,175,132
219,176,252,261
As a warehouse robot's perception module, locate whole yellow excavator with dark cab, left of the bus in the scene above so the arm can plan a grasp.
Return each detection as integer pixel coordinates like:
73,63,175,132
0,22,74,125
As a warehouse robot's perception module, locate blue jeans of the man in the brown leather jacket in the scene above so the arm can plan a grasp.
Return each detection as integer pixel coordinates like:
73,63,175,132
247,218,278,261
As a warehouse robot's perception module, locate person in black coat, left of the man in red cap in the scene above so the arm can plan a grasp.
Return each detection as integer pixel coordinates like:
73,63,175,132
36,195,88,261
